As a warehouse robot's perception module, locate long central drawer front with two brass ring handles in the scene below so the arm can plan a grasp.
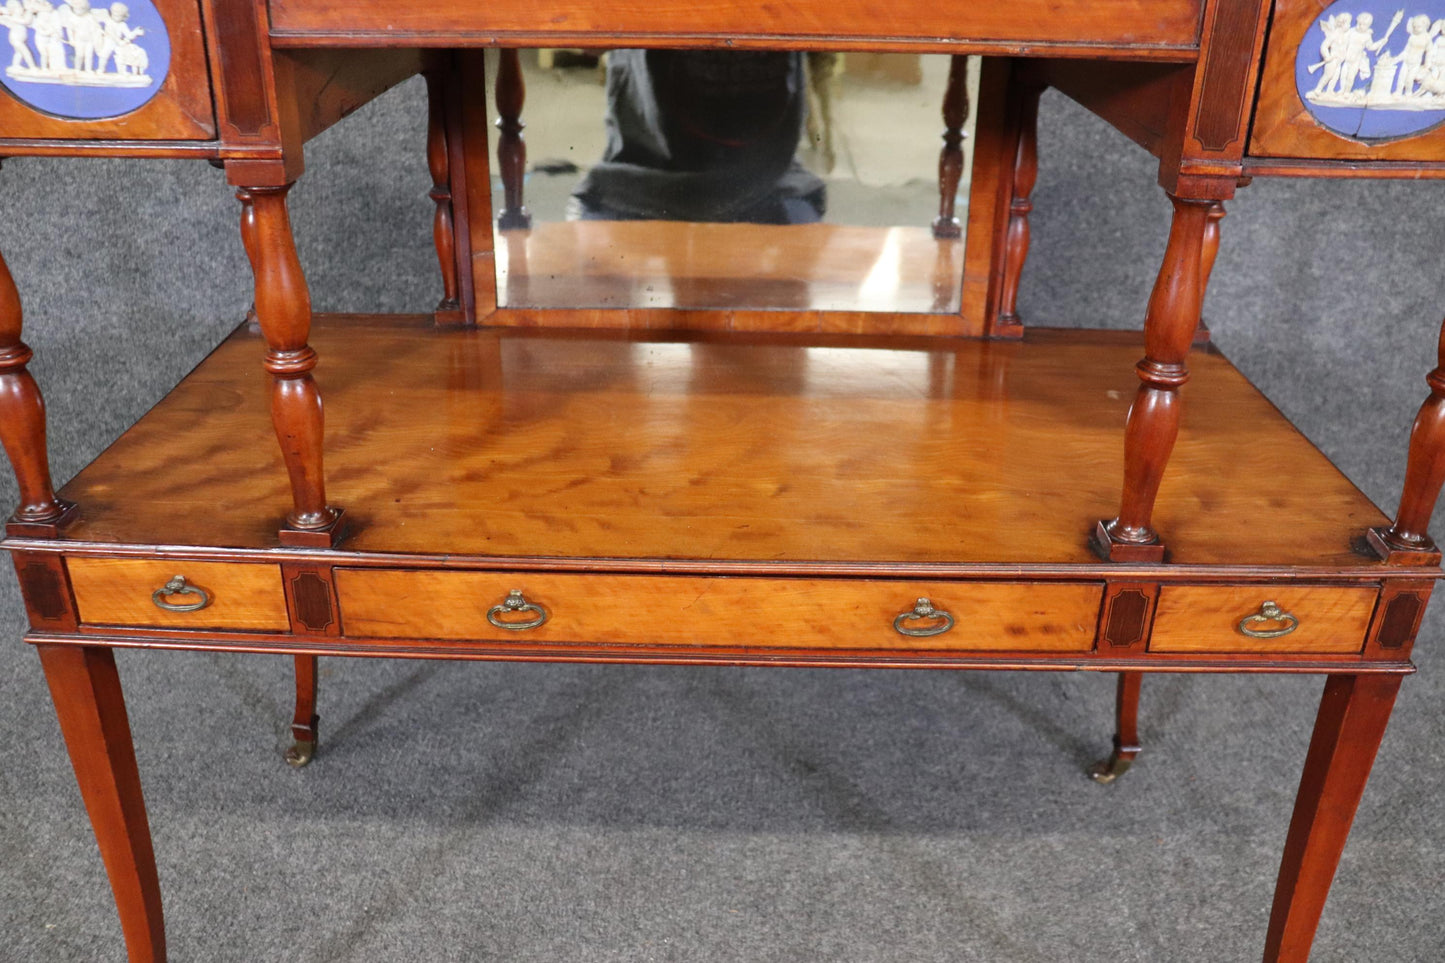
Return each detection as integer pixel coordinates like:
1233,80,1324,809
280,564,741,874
335,568,1103,652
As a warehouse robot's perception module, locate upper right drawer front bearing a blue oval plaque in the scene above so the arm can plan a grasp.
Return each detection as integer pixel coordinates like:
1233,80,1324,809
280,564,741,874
1250,0,1445,161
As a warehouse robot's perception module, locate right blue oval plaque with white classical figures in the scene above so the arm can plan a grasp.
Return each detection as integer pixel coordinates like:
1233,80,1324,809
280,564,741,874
1295,0,1445,140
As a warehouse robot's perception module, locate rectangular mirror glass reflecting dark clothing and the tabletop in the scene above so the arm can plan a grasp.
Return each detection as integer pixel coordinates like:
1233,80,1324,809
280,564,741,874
488,49,977,312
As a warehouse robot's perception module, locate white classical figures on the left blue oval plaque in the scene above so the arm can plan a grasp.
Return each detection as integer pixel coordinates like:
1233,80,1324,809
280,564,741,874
0,0,152,87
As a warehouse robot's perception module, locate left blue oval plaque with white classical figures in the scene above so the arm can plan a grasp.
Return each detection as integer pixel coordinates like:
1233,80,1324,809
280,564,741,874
0,0,171,120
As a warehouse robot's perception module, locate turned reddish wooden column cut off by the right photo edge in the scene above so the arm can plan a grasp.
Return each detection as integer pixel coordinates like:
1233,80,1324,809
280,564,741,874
1366,307,1445,565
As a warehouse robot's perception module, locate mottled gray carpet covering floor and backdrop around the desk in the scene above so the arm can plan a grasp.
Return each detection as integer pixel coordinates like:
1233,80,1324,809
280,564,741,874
0,76,1445,963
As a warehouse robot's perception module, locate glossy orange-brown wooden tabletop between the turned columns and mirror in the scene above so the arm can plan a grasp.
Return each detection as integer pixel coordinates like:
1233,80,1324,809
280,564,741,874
53,318,1386,567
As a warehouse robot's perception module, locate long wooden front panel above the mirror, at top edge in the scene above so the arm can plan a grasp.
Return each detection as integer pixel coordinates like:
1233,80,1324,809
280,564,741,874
270,0,1202,61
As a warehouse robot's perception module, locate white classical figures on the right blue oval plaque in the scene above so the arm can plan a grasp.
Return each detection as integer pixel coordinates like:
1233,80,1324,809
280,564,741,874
1305,10,1445,110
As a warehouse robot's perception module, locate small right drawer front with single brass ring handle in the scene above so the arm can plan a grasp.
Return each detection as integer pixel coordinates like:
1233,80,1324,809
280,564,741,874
1149,584,1377,652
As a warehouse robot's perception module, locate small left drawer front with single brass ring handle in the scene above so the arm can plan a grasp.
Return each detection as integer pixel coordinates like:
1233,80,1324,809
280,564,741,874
65,558,290,632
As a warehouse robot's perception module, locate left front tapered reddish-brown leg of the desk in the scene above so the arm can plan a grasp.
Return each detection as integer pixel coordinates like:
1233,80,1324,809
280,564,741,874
36,645,166,963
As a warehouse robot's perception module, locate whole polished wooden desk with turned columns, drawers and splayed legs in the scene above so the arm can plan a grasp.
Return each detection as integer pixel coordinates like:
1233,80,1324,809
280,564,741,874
0,0,1445,960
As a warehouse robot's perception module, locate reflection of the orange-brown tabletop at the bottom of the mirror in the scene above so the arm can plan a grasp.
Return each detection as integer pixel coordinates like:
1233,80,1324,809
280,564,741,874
496,221,964,313
